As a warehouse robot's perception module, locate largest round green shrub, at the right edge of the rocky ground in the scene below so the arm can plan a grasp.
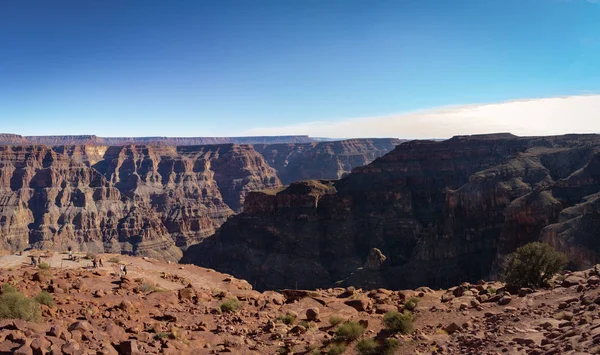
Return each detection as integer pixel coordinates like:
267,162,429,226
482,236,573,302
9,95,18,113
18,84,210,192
502,242,567,288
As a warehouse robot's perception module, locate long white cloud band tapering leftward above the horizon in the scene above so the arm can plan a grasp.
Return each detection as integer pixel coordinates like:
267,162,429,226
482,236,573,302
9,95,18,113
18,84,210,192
244,95,600,138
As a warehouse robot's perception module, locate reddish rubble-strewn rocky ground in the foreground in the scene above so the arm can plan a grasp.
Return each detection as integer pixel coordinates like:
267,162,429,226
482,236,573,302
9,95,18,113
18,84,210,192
0,253,600,354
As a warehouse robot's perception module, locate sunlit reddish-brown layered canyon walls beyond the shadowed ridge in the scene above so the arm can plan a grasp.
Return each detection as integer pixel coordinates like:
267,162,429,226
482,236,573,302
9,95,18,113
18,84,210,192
0,135,401,261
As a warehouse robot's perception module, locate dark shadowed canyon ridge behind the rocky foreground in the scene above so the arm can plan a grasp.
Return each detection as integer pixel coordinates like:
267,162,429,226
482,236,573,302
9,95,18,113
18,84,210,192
184,134,600,289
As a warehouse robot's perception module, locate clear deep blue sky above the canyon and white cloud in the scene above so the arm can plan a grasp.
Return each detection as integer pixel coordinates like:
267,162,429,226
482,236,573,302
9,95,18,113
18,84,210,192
0,0,600,137
